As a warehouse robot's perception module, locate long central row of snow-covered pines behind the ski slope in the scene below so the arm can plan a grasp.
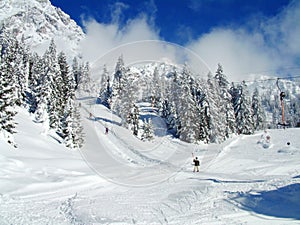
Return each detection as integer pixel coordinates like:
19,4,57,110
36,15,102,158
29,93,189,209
99,56,266,143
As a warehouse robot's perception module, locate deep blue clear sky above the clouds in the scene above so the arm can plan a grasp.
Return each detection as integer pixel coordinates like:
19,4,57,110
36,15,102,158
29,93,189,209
51,0,290,44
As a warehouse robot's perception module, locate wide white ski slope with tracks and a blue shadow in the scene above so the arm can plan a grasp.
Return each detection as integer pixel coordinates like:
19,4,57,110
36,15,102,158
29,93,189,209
0,98,300,225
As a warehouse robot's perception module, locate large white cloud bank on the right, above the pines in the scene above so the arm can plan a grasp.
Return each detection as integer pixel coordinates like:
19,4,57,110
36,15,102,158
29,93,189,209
188,1,300,80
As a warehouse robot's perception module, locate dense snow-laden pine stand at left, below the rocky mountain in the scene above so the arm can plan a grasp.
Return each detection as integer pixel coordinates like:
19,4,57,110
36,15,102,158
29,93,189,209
0,31,89,148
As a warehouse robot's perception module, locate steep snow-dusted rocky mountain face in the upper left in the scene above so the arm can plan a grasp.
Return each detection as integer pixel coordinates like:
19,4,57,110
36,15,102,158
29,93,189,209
0,0,84,57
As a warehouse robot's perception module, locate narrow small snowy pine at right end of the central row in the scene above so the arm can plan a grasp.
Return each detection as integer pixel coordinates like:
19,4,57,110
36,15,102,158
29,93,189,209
251,88,266,130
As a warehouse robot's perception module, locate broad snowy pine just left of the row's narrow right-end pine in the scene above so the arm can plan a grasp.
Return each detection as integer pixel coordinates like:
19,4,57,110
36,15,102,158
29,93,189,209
230,81,254,134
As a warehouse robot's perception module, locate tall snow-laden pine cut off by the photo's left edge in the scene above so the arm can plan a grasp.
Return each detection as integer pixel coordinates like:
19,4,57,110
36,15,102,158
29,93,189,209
0,33,17,144
